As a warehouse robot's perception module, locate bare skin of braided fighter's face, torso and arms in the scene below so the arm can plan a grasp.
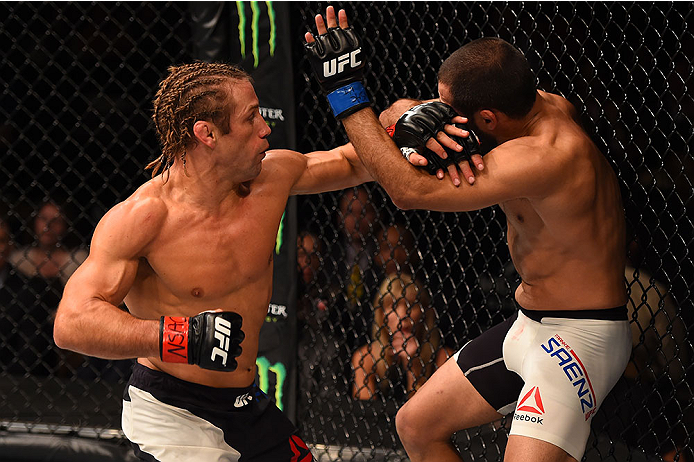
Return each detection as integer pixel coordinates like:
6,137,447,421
54,81,371,387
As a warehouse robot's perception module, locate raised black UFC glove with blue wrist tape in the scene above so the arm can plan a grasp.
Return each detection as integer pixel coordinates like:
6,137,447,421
304,27,371,119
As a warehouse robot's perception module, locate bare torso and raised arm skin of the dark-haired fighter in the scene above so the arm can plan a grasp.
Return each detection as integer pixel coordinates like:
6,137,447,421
343,86,626,310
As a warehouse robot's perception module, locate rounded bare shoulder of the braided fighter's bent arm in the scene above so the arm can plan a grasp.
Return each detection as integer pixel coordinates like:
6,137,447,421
94,180,169,253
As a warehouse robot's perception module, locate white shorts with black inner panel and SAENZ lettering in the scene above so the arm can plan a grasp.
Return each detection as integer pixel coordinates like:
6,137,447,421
454,306,631,460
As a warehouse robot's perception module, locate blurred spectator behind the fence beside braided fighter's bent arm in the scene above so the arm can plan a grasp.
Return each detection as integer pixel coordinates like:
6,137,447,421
10,201,87,285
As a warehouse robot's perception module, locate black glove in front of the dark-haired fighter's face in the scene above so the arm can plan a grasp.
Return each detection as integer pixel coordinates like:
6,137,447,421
392,101,480,175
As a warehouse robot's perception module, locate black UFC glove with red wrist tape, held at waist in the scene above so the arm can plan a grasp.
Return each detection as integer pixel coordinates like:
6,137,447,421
159,311,246,372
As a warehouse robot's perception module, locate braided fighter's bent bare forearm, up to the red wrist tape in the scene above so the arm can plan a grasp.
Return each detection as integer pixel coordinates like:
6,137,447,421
53,299,159,359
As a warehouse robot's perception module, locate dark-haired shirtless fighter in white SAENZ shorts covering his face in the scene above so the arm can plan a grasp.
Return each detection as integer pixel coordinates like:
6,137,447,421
305,8,630,462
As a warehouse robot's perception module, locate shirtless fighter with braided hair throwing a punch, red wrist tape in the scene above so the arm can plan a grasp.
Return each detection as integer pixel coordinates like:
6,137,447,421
54,63,392,462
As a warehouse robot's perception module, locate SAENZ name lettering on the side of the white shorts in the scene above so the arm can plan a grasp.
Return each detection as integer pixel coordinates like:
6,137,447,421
540,334,598,420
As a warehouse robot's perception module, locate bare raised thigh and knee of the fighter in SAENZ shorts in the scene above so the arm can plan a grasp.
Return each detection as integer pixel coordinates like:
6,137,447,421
397,358,502,439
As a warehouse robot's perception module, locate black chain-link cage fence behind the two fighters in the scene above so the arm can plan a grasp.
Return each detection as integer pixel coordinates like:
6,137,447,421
0,2,694,461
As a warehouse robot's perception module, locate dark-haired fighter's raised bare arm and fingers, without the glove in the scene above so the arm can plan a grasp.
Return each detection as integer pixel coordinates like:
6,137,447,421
305,7,565,211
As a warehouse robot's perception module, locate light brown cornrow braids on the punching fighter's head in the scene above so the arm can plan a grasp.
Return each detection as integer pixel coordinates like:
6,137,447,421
145,62,252,178
